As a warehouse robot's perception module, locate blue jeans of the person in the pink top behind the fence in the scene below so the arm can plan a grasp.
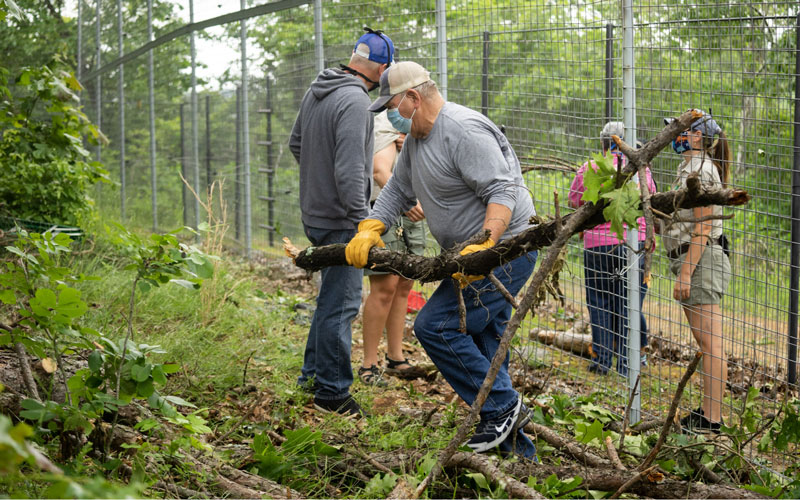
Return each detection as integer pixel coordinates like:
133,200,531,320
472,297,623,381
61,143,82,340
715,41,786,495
583,245,647,375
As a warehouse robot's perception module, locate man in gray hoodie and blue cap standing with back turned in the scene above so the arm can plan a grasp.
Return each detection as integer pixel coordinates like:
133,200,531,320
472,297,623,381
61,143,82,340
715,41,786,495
289,28,394,416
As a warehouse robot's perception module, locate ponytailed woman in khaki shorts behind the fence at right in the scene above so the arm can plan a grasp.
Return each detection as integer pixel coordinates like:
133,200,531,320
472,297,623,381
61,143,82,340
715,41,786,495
661,111,731,433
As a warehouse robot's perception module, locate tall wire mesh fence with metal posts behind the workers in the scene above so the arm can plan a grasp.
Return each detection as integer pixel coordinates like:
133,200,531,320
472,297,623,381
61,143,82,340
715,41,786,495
79,0,800,464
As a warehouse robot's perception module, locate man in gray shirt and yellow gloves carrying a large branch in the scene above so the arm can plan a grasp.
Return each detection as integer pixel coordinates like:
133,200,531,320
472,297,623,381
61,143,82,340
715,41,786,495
346,62,536,458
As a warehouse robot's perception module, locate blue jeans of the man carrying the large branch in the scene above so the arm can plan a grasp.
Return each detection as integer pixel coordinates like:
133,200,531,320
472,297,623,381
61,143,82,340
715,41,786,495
414,252,536,458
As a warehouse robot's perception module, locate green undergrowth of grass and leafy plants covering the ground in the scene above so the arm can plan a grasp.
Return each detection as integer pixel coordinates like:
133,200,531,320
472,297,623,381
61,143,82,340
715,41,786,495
0,229,800,498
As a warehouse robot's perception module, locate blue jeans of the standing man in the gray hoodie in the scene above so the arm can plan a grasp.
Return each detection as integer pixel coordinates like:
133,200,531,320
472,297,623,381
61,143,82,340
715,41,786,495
297,225,364,399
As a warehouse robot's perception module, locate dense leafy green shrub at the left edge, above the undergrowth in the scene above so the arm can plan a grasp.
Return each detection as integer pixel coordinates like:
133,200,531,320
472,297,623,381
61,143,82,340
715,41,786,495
0,61,108,225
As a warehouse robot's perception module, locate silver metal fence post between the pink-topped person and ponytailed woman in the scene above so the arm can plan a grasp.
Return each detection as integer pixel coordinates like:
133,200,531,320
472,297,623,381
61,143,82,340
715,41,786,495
622,0,647,424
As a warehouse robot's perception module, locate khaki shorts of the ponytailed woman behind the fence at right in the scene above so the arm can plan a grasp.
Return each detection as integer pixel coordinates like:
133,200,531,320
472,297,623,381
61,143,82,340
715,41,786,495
669,245,731,306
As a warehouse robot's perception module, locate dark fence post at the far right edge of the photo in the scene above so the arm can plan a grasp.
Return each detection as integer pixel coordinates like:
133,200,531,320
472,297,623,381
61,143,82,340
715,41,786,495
786,14,800,385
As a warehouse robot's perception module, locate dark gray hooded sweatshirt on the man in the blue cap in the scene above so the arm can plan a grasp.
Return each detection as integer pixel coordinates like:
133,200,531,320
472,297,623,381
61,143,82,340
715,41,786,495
289,69,373,229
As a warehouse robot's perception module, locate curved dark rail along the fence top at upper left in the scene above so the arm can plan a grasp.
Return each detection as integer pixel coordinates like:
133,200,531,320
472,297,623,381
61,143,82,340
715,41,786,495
82,0,311,84
